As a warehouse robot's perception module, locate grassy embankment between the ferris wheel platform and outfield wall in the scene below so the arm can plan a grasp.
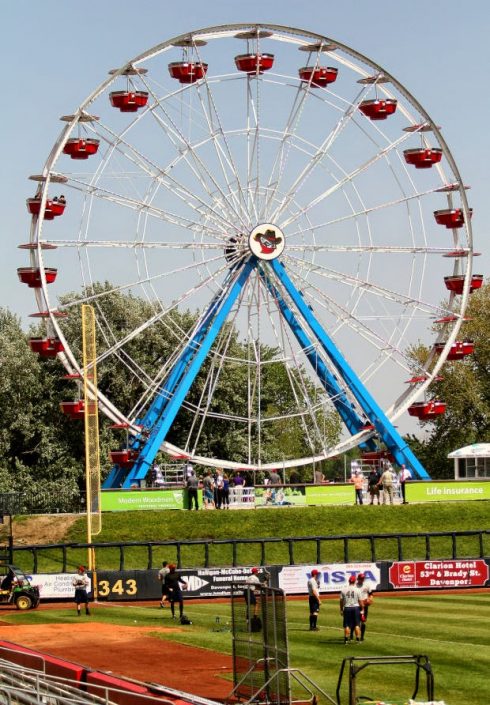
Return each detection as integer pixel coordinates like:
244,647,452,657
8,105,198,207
14,501,490,572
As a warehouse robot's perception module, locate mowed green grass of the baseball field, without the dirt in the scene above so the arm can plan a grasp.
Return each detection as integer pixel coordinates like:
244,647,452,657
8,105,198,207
2,592,490,705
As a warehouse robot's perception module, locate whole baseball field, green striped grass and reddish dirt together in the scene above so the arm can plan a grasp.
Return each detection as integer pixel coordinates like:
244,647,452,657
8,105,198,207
0,590,490,705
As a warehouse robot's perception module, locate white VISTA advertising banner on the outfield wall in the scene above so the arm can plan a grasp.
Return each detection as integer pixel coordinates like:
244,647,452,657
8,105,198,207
279,563,381,595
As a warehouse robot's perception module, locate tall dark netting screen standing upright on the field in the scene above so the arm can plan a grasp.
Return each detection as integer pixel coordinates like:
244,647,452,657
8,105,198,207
231,583,291,705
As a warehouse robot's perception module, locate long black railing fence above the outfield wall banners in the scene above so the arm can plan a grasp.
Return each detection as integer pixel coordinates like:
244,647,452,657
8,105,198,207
4,529,490,573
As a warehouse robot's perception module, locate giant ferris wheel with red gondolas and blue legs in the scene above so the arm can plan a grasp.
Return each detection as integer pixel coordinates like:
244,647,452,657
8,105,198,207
18,24,483,487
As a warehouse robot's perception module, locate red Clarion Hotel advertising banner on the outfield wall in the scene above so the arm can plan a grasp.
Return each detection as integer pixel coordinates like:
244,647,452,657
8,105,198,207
389,559,488,590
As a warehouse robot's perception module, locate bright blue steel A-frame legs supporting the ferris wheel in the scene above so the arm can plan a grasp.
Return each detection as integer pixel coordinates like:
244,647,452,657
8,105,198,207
104,256,429,489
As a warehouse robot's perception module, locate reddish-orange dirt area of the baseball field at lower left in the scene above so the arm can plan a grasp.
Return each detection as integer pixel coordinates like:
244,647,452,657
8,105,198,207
1,617,233,700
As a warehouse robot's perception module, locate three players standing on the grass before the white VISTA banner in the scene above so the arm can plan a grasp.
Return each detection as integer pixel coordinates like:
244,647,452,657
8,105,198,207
308,568,373,644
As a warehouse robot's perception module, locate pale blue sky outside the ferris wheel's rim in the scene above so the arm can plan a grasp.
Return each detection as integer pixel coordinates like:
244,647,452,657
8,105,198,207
0,0,490,440
